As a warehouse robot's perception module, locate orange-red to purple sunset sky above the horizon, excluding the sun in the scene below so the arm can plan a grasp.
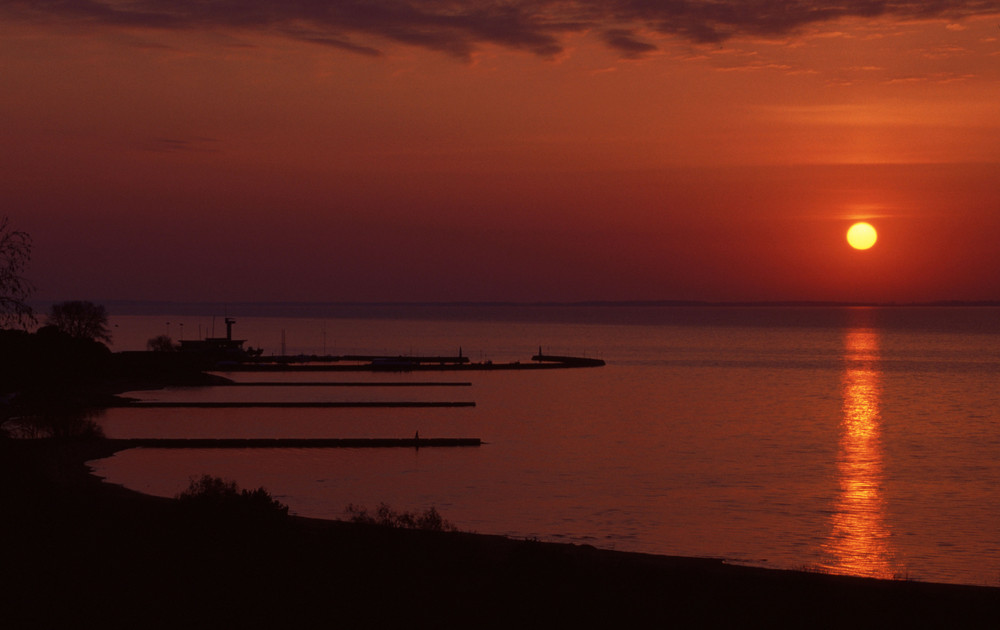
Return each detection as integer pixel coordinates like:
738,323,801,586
0,0,1000,301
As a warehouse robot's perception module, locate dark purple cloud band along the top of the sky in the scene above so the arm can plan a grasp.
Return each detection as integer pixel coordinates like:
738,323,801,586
0,0,1000,59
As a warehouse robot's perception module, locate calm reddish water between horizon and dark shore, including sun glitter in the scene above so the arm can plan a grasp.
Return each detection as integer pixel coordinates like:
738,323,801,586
93,307,1000,586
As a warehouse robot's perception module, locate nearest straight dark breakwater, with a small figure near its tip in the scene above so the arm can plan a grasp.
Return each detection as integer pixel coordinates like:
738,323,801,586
106,438,483,451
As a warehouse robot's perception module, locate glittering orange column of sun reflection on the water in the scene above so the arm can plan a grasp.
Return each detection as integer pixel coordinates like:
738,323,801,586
823,328,896,578
